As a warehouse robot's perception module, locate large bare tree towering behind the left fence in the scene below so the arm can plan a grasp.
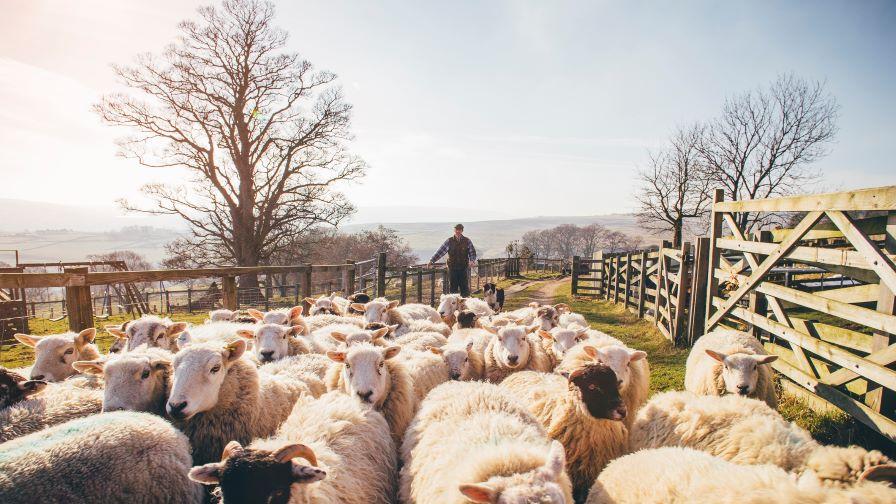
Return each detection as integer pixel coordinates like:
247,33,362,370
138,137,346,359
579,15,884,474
96,0,365,287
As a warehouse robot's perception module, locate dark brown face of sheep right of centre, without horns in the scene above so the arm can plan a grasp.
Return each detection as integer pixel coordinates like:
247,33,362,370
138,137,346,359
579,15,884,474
561,363,627,420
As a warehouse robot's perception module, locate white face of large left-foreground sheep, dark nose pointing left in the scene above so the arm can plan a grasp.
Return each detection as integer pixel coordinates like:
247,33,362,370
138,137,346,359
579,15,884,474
165,339,246,420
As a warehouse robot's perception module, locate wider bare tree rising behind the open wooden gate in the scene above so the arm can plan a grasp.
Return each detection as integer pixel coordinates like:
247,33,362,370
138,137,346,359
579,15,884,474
699,75,839,231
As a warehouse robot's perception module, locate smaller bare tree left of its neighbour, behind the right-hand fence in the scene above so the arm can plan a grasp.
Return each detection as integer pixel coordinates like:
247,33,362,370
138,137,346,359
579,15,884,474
636,125,712,247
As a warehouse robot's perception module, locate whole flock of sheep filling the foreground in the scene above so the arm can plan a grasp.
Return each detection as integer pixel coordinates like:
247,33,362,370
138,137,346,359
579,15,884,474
0,294,896,504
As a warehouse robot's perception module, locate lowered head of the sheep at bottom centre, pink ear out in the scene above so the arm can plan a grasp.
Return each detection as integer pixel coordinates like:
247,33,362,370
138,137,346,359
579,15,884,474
458,441,572,504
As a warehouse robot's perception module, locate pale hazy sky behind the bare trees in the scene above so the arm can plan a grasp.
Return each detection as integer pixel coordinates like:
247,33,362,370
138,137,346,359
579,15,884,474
0,0,896,221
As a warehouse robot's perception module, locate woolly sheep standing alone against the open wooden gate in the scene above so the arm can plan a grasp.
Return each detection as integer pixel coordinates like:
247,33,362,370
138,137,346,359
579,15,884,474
684,330,778,408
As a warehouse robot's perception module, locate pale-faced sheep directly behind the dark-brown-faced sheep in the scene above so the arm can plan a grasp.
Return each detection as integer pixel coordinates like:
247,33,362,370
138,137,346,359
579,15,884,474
556,340,650,427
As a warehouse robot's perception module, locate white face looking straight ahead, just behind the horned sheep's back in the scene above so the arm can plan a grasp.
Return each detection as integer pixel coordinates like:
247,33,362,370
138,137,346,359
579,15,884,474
327,343,401,406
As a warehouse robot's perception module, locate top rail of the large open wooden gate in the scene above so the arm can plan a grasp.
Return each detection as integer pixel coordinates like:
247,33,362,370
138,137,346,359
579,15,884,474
712,186,896,215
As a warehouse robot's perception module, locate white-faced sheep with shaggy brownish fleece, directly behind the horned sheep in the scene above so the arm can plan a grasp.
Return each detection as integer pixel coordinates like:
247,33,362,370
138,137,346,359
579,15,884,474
165,339,310,464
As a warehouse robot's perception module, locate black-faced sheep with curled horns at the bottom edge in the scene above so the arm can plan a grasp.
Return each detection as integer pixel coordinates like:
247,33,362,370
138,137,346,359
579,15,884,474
189,392,397,504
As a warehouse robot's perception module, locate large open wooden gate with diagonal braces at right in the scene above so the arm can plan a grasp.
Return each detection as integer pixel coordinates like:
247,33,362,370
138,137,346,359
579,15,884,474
706,186,896,439
